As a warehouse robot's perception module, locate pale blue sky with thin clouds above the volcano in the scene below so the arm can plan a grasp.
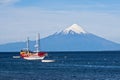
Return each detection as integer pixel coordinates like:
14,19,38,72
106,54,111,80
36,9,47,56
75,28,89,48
0,0,120,44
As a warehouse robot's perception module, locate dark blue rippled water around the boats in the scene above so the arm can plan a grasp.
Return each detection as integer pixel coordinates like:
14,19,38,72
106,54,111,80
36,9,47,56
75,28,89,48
0,51,120,80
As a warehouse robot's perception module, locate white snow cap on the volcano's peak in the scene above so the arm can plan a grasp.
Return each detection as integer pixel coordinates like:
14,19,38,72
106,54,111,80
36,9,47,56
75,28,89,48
62,24,87,34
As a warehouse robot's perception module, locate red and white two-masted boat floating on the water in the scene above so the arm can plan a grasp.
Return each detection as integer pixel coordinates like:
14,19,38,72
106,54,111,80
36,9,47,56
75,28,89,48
20,34,47,60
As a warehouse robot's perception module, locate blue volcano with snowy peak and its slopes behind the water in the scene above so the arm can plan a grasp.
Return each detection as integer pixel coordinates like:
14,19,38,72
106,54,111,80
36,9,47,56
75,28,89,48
0,24,120,51
